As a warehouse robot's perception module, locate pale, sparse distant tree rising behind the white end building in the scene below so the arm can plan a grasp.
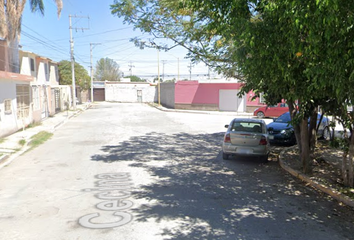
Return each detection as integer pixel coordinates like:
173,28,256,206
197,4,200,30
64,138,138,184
94,58,121,81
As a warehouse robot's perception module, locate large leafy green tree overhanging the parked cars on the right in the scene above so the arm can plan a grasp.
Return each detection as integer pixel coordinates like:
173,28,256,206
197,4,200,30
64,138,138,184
111,0,354,182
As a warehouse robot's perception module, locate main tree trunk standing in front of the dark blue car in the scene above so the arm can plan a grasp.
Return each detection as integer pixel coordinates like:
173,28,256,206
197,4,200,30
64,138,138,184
301,119,311,173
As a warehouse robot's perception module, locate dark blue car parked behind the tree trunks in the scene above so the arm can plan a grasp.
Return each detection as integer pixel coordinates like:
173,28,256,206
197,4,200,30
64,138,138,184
267,112,331,145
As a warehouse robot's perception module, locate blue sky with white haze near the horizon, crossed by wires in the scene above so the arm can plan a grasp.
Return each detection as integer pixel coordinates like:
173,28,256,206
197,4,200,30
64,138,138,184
20,0,214,80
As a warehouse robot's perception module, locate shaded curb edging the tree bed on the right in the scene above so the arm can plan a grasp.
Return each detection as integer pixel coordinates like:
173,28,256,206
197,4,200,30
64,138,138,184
278,149,354,208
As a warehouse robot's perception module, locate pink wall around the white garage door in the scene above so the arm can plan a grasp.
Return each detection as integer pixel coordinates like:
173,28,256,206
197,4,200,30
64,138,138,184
175,81,242,104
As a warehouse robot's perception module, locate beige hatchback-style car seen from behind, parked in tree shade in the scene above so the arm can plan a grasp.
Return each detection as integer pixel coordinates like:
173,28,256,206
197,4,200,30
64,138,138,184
222,118,270,162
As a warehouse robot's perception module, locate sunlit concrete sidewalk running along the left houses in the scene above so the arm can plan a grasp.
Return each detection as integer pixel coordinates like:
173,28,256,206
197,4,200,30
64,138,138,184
0,103,91,169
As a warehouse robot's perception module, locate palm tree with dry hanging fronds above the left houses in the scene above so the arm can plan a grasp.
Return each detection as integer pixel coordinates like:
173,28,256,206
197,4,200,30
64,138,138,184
0,0,63,73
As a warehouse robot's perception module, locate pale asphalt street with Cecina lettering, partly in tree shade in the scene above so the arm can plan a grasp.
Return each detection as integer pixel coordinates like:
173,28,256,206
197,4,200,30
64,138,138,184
0,103,354,240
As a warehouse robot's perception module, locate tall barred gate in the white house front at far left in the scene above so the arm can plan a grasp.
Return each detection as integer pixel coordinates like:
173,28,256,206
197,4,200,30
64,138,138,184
16,84,31,119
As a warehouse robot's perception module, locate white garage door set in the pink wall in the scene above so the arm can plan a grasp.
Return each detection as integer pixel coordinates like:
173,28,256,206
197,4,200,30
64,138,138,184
219,89,246,112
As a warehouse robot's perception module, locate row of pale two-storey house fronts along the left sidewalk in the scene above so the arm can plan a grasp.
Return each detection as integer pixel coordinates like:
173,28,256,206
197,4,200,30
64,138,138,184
0,43,72,138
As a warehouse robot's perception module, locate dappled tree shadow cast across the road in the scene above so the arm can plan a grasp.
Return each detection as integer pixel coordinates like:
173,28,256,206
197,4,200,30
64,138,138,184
92,133,353,239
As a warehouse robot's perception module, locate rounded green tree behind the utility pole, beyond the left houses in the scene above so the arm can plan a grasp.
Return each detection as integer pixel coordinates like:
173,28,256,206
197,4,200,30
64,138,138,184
58,60,91,89
